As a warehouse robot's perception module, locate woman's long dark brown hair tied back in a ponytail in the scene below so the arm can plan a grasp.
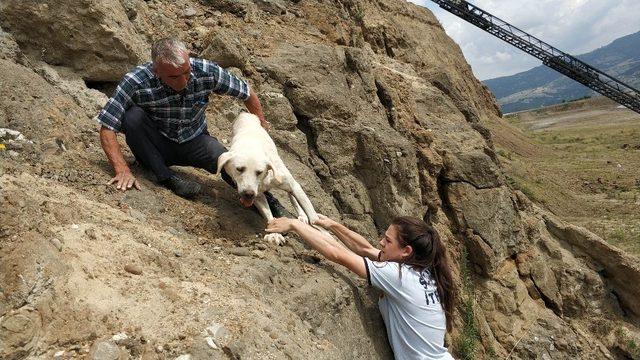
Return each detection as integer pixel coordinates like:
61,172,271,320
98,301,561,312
391,216,456,330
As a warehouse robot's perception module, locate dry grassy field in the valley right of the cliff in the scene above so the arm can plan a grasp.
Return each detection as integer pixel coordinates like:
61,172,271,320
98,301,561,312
491,99,640,255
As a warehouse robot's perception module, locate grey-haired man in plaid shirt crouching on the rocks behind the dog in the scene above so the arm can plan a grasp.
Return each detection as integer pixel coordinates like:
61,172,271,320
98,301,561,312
97,38,281,213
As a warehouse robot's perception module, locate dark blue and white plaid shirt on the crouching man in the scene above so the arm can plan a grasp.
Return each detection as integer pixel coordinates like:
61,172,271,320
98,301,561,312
96,58,249,143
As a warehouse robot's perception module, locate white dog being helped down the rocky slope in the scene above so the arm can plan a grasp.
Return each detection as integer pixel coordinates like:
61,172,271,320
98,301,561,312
218,113,318,245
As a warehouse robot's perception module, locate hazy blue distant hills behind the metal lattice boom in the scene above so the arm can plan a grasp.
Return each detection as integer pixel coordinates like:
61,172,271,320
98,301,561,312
484,31,640,113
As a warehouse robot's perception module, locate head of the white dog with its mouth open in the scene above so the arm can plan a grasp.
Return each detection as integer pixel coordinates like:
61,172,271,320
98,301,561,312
218,151,279,207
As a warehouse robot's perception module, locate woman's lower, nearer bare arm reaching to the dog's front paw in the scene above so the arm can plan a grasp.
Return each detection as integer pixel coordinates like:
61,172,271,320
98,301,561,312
265,218,367,278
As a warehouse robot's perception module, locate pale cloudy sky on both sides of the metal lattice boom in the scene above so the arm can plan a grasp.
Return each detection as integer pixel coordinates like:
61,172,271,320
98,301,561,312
409,0,640,80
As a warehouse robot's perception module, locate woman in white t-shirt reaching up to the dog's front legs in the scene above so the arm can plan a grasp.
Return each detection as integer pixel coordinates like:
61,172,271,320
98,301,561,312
266,215,455,359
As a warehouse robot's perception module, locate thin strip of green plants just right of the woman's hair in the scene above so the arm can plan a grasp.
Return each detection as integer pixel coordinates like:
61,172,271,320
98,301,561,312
456,249,480,360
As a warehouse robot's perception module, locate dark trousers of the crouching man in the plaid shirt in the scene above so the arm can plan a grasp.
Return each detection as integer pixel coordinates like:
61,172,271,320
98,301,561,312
122,106,236,184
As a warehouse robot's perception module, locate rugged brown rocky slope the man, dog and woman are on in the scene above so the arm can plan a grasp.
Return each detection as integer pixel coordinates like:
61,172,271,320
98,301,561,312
0,0,640,359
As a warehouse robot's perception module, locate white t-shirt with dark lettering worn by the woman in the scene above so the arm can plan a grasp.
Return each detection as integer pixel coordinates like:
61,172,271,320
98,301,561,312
364,258,453,360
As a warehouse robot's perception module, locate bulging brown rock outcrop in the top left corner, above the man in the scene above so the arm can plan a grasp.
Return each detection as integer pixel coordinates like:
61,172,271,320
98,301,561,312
0,0,149,81
